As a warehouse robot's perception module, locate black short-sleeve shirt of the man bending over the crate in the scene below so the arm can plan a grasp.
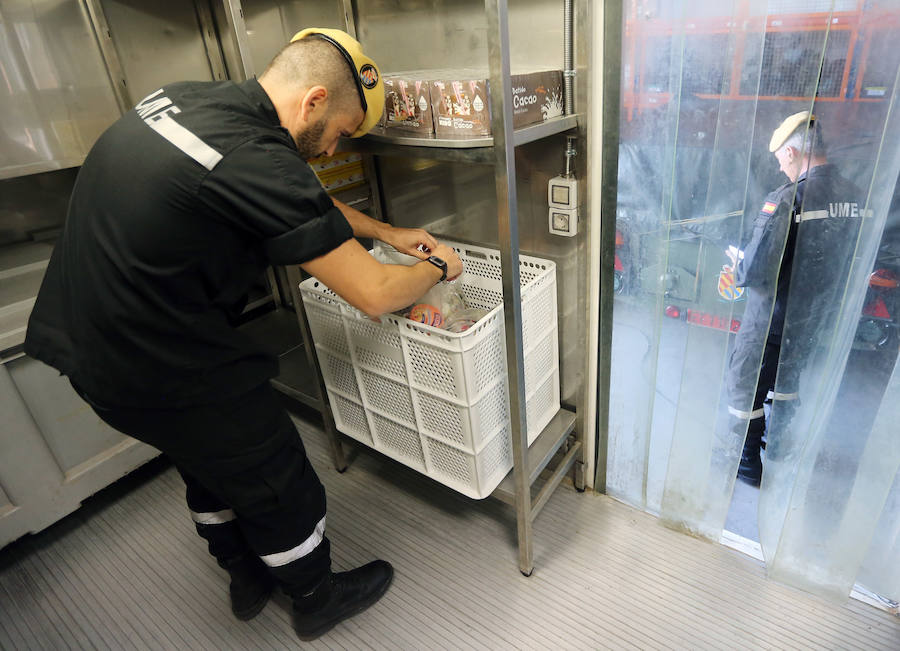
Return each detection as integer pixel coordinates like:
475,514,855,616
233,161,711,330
25,80,353,408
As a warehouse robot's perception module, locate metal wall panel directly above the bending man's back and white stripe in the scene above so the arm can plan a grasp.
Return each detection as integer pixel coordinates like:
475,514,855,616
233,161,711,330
100,0,215,102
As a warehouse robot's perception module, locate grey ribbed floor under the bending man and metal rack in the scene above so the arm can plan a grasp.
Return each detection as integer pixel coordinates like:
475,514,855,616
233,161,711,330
0,404,900,649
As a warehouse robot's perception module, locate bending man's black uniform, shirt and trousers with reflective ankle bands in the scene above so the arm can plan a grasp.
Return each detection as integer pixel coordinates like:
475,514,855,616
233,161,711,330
25,80,353,593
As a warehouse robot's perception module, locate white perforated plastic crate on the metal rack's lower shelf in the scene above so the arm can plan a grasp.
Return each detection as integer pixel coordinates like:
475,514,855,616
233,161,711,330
300,242,559,499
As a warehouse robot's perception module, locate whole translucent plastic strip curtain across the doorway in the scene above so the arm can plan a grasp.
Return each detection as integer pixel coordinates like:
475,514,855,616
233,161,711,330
607,0,900,601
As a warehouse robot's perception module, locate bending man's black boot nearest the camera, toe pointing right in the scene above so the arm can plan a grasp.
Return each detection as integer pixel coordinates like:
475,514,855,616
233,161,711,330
292,561,394,640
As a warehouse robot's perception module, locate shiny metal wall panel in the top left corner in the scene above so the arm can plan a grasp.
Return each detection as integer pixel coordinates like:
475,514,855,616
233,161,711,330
0,0,119,178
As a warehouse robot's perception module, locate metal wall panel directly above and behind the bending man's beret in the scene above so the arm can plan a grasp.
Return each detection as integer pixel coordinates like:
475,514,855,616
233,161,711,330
241,0,346,75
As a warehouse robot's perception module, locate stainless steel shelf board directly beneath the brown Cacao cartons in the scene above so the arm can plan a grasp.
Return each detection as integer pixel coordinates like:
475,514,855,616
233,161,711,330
339,115,579,164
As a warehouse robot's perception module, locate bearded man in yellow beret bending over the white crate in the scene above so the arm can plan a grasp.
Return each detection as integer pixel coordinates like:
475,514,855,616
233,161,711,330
25,29,462,639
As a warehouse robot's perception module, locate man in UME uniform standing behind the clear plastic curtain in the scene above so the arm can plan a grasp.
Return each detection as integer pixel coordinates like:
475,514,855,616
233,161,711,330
728,111,865,486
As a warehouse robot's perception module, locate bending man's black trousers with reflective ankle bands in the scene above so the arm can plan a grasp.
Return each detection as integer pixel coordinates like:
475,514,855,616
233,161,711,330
73,383,331,595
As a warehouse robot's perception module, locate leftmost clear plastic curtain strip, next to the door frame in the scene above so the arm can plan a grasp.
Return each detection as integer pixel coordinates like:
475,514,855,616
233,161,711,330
607,3,684,512
